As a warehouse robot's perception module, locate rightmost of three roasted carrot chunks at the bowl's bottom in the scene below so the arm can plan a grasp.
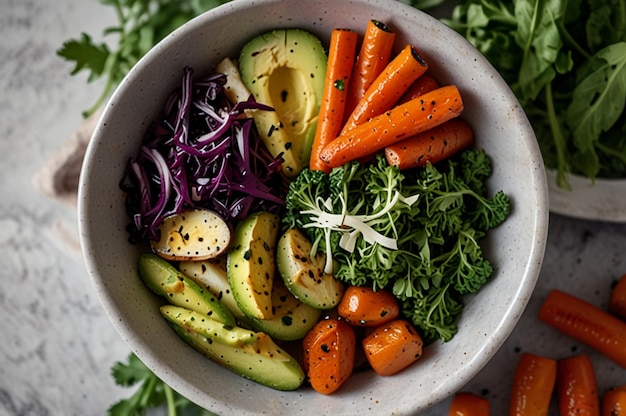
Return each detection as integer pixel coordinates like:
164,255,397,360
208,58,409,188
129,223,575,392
362,319,423,376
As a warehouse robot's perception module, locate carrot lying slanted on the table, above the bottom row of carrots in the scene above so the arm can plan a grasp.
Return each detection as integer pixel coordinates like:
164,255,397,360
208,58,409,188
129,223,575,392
539,289,626,368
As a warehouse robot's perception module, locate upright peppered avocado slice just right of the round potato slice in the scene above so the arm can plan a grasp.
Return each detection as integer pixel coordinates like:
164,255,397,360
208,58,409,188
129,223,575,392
226,211,280,319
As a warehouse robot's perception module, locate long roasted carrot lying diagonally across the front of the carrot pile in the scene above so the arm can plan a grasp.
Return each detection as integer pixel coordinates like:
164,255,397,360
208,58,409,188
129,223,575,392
320,85,463,168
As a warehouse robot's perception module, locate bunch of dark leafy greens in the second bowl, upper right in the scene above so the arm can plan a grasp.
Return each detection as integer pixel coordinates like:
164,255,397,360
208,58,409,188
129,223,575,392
443,0,626,188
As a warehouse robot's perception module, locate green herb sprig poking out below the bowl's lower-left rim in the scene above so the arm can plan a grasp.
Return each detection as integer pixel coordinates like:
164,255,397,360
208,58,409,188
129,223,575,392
107,353,213,416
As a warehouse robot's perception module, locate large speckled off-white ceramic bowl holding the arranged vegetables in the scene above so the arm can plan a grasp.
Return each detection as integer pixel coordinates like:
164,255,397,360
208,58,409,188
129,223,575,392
79,0,548,415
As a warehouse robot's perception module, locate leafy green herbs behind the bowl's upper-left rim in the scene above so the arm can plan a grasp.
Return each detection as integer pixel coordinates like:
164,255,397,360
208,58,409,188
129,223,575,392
57,0,229,116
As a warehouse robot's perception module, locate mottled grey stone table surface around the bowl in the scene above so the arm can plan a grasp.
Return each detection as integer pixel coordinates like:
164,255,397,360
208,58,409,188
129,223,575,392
0,0,626,416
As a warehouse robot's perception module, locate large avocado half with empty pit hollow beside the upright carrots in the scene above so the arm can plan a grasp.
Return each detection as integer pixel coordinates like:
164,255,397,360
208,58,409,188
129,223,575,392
239,29,328,177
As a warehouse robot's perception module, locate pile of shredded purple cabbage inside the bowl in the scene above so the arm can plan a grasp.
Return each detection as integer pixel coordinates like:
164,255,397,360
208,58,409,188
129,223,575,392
120,67,287,242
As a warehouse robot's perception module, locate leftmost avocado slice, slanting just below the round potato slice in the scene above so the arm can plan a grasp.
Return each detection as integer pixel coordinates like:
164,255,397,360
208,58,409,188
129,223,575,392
138,253,235,326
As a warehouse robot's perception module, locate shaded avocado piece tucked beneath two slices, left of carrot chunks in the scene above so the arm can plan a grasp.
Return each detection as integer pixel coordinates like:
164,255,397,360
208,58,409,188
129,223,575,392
250,277,322,341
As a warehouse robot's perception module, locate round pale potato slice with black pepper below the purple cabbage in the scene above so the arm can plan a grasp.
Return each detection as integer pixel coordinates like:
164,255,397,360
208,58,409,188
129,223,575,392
150,209,232,261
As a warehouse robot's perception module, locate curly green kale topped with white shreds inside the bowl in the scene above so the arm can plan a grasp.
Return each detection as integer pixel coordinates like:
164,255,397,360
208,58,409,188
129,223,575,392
283,149,509,342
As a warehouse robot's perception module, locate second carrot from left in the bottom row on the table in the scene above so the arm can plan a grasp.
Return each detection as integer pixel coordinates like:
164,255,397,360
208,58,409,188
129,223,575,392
509,353,557,416
